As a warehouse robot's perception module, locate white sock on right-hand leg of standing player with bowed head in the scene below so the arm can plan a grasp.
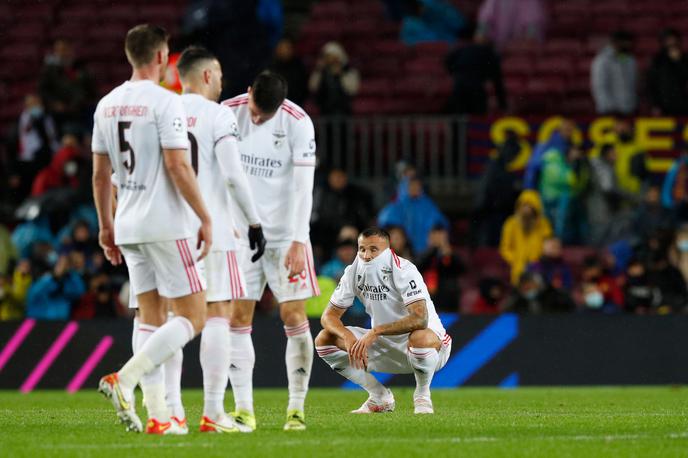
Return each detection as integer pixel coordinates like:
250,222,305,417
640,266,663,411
284,321,313,411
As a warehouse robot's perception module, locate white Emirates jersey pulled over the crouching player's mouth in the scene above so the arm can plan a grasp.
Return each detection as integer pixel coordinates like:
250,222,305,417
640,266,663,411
330,248,445,338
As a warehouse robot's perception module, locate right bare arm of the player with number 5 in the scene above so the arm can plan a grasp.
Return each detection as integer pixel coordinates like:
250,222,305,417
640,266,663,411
163,149,213,261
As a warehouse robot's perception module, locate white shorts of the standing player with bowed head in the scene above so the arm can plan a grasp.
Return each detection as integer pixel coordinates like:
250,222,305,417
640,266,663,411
237,242,320,304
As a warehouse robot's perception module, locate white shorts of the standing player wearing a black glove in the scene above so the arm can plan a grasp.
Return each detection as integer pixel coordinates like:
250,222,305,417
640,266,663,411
204,251,246,302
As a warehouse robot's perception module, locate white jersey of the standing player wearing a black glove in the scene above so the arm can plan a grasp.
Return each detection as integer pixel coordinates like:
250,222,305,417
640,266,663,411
182,94,241,251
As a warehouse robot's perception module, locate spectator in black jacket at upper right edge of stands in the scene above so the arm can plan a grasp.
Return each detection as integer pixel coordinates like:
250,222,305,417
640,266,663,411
647,29,688,116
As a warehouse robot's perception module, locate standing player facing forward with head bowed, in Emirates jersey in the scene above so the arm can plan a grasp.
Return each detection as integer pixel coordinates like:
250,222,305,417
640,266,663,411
223,71,320,431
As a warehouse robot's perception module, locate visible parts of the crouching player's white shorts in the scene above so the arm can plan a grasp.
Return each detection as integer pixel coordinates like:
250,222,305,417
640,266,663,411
346,326,452,374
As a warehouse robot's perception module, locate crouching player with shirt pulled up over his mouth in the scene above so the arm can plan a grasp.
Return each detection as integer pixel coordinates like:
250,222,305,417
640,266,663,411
315,228,451,414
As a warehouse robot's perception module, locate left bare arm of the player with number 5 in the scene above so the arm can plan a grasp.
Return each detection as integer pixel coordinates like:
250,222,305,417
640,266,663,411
93,152,122,265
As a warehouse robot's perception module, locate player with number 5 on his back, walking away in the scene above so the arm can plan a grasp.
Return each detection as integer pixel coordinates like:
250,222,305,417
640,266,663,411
92,25,212,434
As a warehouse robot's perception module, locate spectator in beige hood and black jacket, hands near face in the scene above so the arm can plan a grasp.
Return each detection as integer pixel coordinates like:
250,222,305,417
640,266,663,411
308,41,360,116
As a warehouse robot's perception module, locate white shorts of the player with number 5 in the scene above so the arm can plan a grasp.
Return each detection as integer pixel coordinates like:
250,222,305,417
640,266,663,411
119,239,206,300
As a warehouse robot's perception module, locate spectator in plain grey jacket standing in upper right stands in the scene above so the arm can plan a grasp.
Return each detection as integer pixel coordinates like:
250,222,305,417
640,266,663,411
590,31,638,115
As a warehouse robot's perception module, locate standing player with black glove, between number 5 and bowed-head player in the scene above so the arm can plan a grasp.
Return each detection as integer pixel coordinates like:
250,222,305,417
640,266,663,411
177,47,265,432
